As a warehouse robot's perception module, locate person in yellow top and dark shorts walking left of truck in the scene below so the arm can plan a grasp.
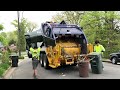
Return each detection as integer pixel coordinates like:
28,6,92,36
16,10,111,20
30,44,40,78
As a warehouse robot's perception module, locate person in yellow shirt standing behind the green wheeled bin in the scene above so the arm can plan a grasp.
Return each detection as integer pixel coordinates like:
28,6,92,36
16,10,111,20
94,40,105,68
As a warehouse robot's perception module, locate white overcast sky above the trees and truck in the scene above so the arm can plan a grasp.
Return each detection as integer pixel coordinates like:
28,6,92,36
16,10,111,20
0,11,61,32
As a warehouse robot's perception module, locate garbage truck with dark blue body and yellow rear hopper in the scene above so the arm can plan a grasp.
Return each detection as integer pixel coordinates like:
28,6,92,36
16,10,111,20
25,21,93,69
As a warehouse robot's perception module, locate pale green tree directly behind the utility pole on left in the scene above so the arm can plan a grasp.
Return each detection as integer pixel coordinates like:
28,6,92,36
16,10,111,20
11,18,37,51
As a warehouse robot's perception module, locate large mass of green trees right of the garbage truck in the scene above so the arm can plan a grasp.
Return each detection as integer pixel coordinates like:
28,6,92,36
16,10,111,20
81,11,120,57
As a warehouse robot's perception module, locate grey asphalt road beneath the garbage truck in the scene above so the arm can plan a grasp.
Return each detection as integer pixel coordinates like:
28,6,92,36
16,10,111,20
9,58,120,79
